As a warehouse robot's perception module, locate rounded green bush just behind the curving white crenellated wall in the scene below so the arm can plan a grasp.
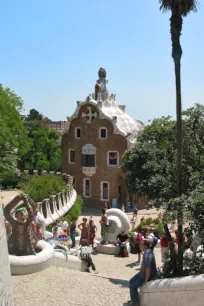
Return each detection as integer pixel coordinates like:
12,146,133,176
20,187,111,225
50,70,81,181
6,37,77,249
20,175,66,202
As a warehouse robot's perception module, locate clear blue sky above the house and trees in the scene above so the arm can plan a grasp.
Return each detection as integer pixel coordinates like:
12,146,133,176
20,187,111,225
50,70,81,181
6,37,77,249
0,0,204,123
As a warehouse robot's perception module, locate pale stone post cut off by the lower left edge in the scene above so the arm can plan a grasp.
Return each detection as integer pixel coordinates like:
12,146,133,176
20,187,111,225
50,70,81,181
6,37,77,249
0,202,14,306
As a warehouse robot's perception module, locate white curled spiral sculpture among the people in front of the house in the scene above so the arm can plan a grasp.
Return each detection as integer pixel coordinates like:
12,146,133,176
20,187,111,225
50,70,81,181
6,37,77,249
105,208,130,243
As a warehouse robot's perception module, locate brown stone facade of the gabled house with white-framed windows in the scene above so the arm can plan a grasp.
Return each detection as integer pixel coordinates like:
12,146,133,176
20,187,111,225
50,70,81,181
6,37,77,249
61,103,127,208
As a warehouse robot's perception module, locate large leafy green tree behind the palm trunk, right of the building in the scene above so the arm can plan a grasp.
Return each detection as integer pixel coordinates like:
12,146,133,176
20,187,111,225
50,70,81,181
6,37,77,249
123,104,204,276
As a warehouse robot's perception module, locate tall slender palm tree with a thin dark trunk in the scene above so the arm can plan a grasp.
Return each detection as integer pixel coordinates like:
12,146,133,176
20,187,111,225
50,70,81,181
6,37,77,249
159,0,197,276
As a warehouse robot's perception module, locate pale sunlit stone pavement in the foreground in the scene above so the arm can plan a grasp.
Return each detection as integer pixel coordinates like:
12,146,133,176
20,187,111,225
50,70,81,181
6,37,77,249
12,248,163,306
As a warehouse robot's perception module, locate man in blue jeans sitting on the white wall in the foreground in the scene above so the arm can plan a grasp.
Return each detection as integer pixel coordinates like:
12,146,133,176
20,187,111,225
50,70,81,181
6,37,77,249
123,239,157,306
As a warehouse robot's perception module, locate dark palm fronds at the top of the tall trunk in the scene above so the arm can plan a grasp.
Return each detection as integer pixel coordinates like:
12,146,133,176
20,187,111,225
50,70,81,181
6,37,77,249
159,0,199,16
